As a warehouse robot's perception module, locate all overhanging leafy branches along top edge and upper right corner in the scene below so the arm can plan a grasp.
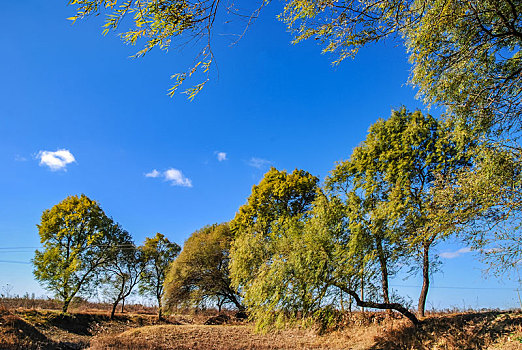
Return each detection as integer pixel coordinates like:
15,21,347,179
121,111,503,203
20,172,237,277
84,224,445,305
69,0,522,135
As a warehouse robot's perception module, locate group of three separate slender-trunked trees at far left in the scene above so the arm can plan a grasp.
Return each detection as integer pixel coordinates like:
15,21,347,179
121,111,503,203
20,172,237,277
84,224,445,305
33,194,181,318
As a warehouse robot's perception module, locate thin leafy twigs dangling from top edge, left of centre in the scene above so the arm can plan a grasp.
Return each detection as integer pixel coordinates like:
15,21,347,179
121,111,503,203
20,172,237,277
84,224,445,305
69,0,264,100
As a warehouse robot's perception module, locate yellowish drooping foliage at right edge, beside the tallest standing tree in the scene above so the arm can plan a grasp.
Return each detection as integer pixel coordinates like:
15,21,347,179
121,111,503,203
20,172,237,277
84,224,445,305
430,142,522,276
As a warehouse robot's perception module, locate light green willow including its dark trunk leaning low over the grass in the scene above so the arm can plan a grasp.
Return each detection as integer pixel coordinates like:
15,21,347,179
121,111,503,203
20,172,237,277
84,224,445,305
231,194,419,329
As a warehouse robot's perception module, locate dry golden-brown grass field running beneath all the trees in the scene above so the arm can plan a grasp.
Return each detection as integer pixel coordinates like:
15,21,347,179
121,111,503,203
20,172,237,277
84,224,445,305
0,307,522,350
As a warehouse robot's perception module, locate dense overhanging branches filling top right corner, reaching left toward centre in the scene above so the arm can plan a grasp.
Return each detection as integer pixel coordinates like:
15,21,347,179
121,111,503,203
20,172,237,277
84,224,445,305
282,0,522,135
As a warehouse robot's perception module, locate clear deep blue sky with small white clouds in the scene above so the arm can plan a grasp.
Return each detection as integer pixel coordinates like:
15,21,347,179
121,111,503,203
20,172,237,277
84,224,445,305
0,0,518,308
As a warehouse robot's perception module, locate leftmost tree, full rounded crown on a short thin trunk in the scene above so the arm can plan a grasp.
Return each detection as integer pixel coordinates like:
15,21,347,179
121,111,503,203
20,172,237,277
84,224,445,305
33,194,126,312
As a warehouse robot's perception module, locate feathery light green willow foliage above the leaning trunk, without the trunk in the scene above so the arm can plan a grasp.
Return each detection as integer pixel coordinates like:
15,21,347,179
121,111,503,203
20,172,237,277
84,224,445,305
234,195,354,330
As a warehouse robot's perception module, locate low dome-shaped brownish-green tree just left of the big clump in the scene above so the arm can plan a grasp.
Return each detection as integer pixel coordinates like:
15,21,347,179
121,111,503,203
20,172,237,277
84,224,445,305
164,223,244,312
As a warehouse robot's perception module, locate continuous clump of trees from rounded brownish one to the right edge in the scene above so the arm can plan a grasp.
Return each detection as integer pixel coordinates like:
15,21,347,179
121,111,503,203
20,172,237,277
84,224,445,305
164,108,522,328
